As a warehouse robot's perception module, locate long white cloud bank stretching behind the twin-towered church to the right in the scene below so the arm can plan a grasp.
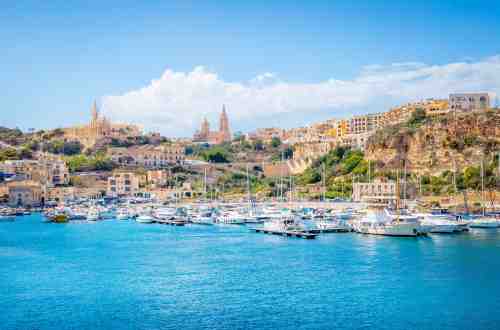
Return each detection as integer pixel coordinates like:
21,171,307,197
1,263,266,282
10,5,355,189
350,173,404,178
102,56,500,136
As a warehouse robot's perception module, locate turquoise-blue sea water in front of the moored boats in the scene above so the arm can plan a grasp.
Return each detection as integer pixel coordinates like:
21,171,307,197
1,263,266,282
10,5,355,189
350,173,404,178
0,215,500,330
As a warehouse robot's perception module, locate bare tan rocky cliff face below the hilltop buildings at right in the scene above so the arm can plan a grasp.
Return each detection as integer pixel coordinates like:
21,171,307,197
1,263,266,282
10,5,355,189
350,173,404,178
365,109,500,174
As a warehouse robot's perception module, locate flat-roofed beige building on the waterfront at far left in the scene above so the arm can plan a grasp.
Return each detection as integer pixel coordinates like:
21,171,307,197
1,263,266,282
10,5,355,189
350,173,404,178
8,180,45,207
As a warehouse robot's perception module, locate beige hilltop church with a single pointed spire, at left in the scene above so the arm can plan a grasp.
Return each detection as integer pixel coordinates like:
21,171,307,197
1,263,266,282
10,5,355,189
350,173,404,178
63,101,142,148
